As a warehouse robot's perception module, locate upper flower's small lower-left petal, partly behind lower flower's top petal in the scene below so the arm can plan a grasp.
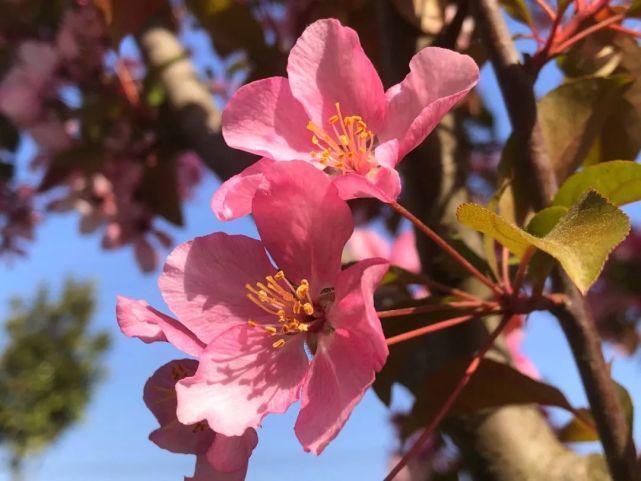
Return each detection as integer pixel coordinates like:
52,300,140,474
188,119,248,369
211,157,274,220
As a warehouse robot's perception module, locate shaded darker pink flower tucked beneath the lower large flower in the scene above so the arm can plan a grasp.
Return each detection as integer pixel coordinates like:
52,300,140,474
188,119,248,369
144,359,258,481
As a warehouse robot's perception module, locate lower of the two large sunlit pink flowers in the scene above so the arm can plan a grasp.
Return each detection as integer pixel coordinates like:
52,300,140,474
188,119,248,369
118,161,388,453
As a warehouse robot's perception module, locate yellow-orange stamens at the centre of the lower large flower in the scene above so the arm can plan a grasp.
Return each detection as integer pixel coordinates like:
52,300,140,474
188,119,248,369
245,271,319,349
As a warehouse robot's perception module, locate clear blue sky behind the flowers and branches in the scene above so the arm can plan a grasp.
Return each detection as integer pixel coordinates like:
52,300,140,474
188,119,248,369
0,50,641,481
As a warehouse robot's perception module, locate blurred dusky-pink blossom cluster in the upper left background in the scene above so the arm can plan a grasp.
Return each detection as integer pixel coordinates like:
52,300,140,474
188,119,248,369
0,2,203,272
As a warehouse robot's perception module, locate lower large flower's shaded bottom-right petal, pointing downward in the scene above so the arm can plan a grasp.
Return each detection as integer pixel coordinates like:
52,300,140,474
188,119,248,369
294,329,375,454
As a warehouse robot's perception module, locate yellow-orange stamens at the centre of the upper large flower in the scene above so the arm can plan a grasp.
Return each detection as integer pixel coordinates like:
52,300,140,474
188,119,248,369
307,102,376,174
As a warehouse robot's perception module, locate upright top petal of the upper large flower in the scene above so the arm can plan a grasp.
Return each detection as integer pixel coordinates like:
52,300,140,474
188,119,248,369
287,19,386,132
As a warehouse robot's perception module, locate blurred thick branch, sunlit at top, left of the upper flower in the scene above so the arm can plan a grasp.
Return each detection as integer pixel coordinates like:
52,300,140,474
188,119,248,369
138,27,254,179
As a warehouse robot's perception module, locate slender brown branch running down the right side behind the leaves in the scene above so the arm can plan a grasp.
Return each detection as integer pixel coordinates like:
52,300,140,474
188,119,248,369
476,0,641,481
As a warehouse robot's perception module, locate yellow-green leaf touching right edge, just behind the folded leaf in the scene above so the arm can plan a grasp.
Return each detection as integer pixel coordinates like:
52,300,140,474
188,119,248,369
552,160,641,207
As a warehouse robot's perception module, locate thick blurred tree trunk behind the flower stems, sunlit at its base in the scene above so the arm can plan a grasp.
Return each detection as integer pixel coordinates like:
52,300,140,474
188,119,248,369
379,0,624,481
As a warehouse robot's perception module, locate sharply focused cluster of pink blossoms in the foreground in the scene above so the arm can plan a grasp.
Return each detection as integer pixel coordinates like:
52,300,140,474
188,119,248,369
117,20,478,479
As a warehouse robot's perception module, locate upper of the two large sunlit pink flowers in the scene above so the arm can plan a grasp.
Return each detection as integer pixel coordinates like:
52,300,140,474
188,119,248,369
216,19,478,217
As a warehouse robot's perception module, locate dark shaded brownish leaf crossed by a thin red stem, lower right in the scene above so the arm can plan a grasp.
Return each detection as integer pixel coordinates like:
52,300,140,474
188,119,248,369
406,358,576,434
